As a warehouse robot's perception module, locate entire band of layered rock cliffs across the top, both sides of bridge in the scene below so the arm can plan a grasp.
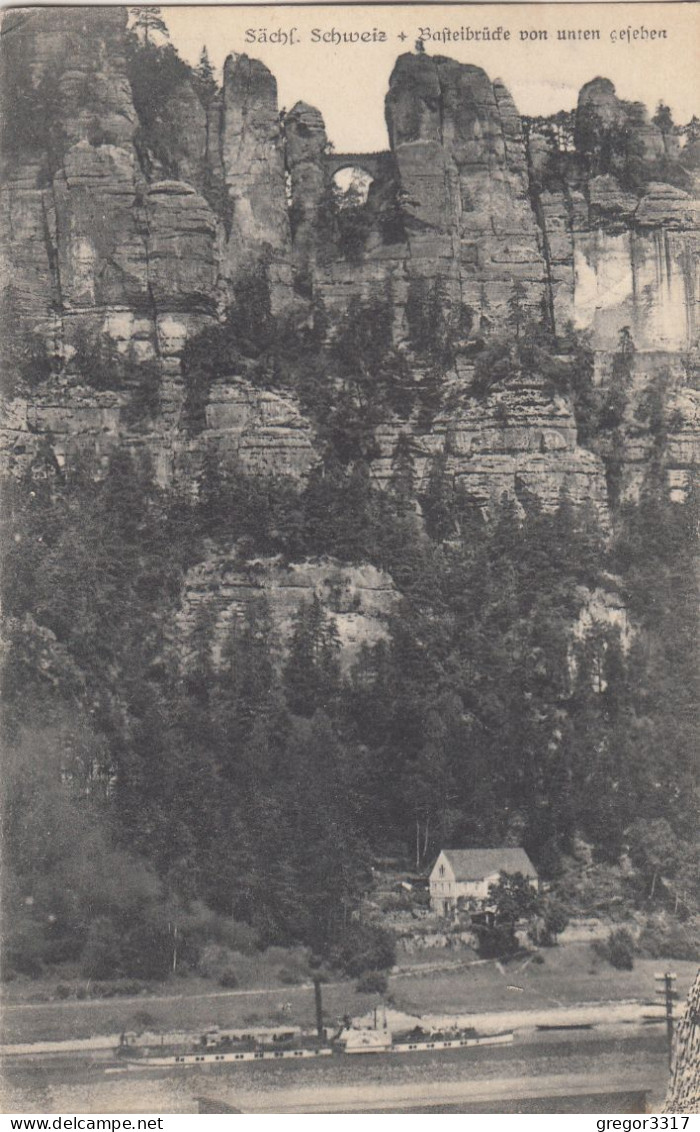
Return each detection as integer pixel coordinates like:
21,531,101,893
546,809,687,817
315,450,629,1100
1,8,698,513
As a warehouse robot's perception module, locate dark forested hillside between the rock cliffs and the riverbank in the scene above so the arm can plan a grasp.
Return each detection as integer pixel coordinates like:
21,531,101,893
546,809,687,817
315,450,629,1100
5,432,697,974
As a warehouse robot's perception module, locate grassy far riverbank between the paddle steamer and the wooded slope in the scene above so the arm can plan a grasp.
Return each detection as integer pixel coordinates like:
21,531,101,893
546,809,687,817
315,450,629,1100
2,944,697,1046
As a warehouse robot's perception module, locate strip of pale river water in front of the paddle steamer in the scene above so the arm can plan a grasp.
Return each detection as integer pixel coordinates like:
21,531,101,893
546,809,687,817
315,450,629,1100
3,1026,668,1114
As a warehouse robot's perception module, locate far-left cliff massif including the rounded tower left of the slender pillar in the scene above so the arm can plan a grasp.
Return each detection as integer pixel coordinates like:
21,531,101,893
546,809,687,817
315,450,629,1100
2,8,217,391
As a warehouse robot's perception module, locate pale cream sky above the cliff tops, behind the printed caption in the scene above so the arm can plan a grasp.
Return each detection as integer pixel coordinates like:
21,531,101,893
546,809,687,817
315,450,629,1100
162,3,700,152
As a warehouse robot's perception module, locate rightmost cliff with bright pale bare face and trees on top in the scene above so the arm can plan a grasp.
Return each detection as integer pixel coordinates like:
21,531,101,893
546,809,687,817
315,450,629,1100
529,78,700,497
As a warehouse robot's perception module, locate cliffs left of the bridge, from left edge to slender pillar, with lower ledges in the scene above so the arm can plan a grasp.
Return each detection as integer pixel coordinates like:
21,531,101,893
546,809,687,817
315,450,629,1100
0,8,309,480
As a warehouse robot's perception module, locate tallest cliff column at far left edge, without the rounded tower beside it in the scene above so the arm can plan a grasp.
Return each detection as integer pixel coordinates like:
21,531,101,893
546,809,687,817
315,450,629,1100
2,9,147,330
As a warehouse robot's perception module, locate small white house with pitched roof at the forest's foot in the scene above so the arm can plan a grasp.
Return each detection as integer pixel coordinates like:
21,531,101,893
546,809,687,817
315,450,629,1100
430,847,539,916
